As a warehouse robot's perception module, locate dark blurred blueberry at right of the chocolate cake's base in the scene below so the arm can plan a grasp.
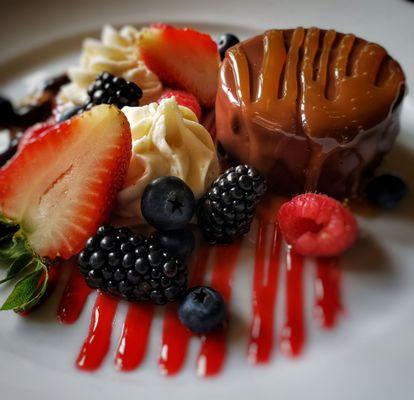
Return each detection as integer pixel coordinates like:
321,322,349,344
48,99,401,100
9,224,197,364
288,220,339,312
365,174,409,210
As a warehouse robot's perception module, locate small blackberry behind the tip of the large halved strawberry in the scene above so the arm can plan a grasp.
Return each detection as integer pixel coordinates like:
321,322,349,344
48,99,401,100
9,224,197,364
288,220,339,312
84,72,142,110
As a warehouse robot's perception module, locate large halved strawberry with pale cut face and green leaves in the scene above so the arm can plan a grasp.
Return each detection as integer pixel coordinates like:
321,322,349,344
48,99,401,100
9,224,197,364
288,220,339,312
0,105,131,310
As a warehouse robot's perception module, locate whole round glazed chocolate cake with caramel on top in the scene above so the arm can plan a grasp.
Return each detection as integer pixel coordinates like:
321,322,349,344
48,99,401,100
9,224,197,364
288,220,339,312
216,28,405,198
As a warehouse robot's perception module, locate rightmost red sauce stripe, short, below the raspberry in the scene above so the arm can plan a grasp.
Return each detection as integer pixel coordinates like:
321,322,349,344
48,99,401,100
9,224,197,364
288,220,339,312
314,258,343,329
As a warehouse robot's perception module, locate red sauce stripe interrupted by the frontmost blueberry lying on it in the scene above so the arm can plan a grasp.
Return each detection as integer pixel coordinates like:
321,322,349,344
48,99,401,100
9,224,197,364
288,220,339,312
197,241,241,376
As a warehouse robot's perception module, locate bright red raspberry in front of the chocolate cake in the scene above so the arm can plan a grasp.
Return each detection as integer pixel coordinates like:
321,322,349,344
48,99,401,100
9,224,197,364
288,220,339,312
278,193,358,257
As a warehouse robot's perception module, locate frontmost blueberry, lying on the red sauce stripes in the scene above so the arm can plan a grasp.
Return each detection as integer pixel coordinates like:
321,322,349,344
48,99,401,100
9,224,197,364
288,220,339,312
178,286,226,334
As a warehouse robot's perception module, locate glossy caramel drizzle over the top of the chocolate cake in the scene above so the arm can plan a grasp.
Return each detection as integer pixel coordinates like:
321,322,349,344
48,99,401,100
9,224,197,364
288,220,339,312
222,28,404,191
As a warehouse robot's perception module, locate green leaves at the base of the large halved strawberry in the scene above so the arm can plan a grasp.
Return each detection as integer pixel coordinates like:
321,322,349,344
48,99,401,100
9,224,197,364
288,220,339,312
0,214,49,312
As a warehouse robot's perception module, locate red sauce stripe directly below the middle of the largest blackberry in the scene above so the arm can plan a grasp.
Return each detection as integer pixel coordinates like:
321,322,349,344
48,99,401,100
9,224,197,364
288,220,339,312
115,303,154,371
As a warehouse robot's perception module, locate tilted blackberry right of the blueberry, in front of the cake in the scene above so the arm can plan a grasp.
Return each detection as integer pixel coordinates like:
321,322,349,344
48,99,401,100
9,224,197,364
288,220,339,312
197,165,266,244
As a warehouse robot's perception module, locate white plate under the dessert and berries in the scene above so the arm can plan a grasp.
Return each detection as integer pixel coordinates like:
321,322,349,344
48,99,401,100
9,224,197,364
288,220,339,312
0,0,414,400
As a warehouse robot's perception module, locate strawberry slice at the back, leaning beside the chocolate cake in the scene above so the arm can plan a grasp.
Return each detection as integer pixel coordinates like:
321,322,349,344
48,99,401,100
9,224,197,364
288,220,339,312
139,24,220,107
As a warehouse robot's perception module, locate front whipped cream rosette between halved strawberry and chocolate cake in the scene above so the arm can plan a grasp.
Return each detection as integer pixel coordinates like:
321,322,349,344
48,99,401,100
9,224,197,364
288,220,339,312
116,98,220,225
